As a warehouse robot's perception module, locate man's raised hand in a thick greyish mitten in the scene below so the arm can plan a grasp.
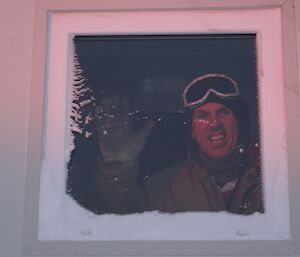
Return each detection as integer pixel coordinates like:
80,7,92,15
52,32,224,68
95,96,155,163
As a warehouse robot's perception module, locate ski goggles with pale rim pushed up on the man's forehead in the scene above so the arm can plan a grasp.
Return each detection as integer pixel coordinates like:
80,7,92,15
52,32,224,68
182,73,240,109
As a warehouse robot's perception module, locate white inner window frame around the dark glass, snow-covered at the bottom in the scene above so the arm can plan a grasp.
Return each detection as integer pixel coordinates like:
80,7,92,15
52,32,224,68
24,1,298,255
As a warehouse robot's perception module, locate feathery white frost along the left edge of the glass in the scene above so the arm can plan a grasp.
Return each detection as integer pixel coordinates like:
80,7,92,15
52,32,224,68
66,40,95,204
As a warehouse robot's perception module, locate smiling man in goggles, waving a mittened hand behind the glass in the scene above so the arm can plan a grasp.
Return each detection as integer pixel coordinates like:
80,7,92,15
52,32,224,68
88,73,263,214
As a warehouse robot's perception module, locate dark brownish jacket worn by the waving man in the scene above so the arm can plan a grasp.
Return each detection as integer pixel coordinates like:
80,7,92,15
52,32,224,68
87,145,264,214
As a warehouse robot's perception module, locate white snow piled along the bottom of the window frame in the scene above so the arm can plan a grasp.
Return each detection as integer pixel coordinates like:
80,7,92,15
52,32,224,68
38,158,289,241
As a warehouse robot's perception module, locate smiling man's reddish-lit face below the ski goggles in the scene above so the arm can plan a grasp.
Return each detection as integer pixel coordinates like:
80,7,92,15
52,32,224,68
192,103,240,159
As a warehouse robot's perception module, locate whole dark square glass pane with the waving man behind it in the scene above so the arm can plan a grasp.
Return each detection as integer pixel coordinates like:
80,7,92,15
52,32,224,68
67,35,264,214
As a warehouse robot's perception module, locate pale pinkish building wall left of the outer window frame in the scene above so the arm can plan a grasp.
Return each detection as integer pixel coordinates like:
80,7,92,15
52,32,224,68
0,0,300,257
